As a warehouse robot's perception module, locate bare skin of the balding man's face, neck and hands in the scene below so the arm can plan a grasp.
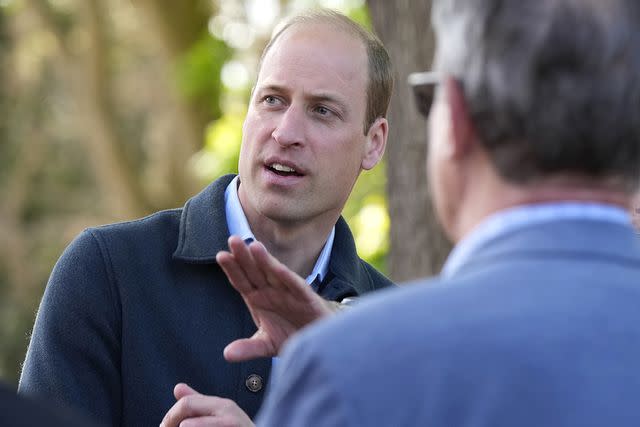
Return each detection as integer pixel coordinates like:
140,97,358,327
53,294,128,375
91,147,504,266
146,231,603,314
161,23,388,427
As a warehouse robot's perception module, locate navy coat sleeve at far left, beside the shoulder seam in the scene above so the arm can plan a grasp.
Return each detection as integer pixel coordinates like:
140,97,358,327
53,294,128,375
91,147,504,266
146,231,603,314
18,230,122,425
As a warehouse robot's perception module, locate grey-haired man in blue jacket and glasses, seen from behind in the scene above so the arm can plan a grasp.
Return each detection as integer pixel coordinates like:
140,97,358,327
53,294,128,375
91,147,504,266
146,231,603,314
252,0,640,427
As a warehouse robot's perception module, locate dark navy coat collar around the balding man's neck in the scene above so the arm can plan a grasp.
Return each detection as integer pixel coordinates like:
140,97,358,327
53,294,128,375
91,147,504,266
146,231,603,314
173,175,375,299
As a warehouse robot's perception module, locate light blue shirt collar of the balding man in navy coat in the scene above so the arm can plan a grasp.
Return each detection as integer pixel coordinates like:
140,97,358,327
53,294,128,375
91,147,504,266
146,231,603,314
224,176,336,283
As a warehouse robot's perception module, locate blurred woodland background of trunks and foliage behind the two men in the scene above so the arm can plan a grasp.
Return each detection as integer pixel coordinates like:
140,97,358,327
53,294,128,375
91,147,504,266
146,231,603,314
0,0,449,384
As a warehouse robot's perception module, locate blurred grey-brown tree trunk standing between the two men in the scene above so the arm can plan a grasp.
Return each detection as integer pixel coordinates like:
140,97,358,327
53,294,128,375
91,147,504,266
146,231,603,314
367,0,451,281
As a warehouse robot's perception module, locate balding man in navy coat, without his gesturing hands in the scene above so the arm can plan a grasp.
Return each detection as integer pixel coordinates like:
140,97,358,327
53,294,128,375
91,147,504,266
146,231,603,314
20,8,392,426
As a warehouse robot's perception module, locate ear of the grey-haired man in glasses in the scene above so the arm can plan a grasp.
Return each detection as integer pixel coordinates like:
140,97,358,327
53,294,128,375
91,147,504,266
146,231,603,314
444,76,476,157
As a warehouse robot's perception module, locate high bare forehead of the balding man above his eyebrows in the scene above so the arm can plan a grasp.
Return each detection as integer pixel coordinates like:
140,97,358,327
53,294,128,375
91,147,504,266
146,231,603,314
258,23,368,95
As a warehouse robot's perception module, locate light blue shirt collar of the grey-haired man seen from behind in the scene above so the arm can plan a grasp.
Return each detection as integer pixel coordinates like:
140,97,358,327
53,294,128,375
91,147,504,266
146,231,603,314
440,202,631,277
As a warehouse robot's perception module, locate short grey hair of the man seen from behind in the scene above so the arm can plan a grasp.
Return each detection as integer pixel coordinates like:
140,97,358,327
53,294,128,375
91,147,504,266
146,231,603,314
432,0,640,191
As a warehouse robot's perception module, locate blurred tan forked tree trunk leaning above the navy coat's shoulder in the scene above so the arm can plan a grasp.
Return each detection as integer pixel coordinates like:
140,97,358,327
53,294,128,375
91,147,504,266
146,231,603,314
27,0,149,219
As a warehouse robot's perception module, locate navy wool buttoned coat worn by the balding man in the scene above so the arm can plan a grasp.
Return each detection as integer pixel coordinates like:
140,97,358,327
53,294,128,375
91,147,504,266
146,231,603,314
19,175,391,426
